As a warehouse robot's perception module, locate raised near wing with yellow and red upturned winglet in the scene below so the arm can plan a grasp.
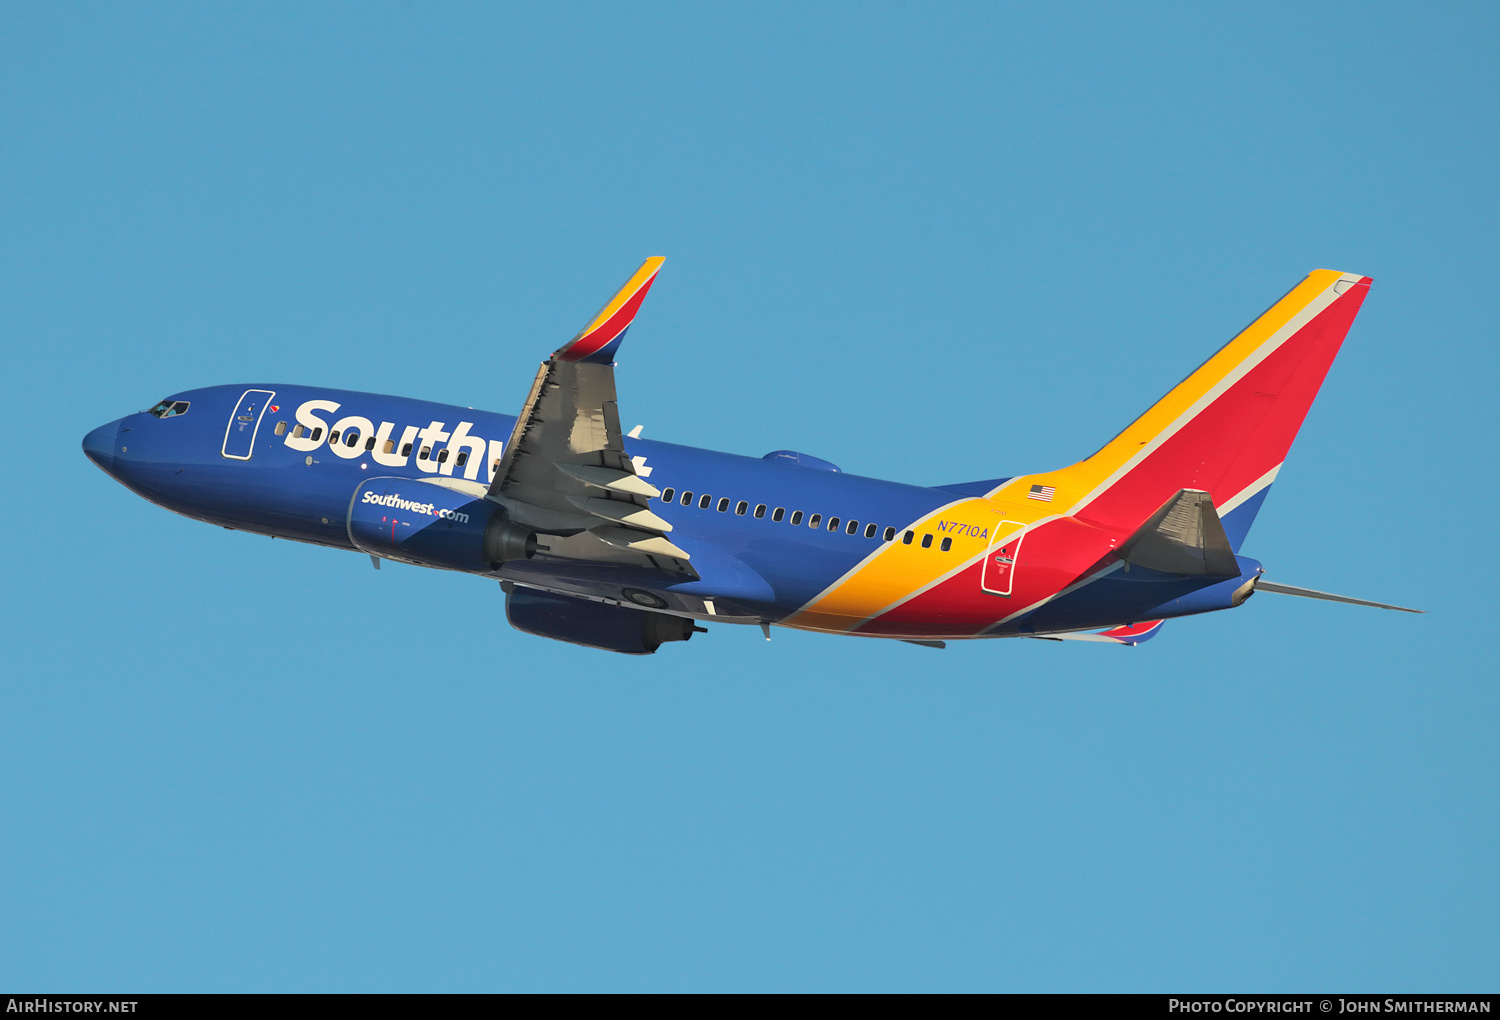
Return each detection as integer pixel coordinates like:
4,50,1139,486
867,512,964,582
488,258,689,569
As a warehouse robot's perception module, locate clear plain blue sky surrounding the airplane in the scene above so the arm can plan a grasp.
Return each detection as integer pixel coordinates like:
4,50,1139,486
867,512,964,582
0,3,1500,992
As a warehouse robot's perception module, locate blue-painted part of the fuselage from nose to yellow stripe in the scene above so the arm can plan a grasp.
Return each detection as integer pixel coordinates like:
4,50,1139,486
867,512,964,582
86,384,972,620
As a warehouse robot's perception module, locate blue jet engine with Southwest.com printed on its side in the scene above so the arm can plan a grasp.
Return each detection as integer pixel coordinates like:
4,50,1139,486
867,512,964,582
348,479,537,573
